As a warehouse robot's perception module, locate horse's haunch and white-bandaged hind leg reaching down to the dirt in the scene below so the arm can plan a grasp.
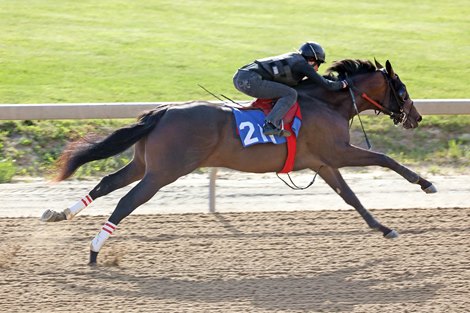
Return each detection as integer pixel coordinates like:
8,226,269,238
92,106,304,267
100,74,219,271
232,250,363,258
90,107,227,264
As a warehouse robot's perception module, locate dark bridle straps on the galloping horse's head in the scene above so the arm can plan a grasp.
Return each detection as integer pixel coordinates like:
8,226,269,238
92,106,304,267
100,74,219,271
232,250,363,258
348,69,411,125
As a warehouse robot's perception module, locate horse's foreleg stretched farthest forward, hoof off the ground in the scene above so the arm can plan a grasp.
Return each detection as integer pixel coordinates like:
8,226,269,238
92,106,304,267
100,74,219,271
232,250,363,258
336,146,437,193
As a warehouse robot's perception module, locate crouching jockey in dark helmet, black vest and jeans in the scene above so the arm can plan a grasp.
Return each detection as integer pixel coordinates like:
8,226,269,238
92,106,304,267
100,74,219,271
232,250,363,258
233,42,348,137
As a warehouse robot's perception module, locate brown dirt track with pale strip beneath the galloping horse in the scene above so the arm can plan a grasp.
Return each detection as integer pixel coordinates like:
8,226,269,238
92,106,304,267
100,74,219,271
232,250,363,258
0,169,470,313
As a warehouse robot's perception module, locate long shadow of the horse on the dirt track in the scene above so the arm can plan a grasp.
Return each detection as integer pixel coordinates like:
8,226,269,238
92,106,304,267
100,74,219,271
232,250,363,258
68,259,442,311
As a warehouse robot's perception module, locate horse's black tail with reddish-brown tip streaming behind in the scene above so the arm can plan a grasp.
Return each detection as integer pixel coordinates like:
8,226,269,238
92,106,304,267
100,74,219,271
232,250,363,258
54,105,169,181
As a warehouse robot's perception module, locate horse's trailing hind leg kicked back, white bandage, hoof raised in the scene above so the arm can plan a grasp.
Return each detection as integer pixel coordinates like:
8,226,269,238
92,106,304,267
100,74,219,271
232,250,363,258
41,141,145,222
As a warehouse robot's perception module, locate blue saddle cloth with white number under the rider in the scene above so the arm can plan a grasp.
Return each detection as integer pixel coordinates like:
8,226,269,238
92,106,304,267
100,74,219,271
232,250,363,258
233,108,302,147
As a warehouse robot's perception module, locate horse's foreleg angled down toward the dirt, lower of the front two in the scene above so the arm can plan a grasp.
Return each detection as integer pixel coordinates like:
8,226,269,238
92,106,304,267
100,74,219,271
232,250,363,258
318,166,398,238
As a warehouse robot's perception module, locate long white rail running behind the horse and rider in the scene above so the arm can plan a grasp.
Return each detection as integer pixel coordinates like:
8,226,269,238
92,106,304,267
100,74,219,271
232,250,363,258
0,99,470,120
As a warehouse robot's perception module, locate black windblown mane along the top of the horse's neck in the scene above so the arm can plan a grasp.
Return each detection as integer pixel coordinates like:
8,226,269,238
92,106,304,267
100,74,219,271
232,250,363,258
325,59,376,80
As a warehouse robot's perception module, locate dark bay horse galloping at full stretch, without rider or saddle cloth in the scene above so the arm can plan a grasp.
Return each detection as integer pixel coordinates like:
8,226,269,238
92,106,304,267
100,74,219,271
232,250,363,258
42,59,436,264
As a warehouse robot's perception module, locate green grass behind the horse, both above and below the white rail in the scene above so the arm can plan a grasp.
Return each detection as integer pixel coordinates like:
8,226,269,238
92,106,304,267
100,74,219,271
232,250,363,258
0,0,470,176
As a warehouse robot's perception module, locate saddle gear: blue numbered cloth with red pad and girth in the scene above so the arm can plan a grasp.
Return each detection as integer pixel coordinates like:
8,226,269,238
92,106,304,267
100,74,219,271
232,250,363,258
232,99,302,173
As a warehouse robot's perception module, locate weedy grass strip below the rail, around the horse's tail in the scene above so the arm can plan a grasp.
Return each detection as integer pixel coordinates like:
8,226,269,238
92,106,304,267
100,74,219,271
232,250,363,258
0,120,133,177
